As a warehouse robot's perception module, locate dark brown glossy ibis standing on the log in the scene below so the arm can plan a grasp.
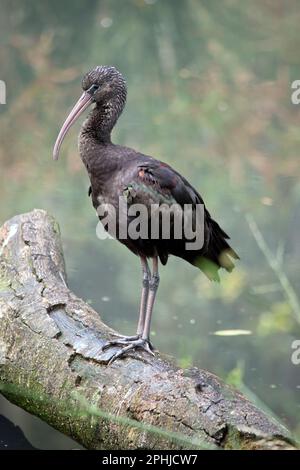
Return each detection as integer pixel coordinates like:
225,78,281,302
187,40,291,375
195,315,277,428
53,65,239,363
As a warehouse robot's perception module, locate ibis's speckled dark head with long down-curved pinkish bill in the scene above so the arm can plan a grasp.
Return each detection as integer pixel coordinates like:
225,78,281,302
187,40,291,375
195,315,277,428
53,65,127,160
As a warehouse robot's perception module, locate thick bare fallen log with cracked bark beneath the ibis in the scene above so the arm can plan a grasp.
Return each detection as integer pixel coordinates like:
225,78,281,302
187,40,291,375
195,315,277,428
0,210,295,449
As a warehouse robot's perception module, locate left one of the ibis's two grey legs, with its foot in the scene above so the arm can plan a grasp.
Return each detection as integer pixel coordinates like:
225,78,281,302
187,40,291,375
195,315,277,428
104,256,151,349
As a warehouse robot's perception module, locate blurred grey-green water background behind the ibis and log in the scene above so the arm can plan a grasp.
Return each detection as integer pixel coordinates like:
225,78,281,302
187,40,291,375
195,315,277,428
0,0,300,448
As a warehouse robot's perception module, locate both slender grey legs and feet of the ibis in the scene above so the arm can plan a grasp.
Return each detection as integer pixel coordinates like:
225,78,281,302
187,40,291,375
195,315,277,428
102,256,159,364
